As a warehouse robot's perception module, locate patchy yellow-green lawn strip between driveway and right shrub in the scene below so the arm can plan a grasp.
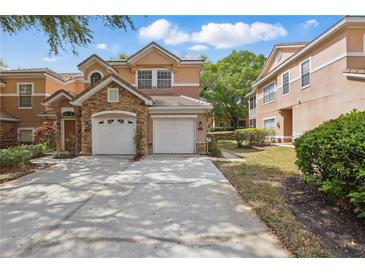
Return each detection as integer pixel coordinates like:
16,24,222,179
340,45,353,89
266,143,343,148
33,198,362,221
216,140,331,257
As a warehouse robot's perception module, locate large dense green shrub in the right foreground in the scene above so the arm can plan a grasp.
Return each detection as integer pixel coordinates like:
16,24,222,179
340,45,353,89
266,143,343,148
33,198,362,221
294,110,365,217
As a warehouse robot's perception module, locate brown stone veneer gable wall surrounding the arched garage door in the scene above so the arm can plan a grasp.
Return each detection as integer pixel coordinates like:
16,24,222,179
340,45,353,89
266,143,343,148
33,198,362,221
81,83,148,155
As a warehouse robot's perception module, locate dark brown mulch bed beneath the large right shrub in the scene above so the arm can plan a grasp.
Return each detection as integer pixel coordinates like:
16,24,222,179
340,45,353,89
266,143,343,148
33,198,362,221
283,177,365,258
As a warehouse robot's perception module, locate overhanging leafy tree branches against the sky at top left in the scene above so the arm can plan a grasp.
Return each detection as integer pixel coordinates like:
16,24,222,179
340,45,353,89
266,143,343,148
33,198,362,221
0,15,135,55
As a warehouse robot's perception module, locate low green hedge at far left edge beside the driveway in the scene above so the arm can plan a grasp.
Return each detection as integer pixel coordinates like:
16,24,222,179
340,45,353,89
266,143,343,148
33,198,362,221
0,144,48,167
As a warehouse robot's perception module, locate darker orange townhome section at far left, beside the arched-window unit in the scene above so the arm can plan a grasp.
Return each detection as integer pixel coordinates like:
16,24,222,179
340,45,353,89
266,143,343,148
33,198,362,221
0,68,84,147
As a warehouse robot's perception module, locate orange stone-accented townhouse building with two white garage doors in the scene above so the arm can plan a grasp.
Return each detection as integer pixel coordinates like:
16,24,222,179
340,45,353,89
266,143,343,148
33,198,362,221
0,43,212,154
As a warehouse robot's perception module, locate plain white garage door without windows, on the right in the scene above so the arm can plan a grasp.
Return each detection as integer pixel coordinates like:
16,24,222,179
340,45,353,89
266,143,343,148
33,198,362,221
153,118,195,153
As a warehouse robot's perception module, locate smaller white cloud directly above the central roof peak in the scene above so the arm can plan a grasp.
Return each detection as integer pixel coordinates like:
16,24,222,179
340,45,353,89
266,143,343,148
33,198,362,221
138,19,189,45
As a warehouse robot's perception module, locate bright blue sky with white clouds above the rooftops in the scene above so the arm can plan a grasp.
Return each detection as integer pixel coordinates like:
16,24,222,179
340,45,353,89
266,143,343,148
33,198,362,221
0,16,341,72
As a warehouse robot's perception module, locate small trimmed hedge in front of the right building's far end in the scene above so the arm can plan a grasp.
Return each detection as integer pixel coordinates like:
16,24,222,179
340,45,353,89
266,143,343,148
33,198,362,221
234,128,275,147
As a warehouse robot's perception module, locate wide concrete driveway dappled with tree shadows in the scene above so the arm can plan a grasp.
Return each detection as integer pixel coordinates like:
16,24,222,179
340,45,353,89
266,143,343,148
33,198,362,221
0,156,289,257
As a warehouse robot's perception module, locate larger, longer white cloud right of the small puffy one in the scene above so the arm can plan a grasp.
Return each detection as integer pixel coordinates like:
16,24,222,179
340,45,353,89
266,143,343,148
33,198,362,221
191,22,288,49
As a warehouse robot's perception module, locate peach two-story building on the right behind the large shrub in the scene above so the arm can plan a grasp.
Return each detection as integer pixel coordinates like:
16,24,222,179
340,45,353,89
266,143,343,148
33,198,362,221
248,16,365,142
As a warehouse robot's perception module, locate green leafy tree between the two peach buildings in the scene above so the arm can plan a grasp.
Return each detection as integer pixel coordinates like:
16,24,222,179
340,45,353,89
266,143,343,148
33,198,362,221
200,50,265,127
